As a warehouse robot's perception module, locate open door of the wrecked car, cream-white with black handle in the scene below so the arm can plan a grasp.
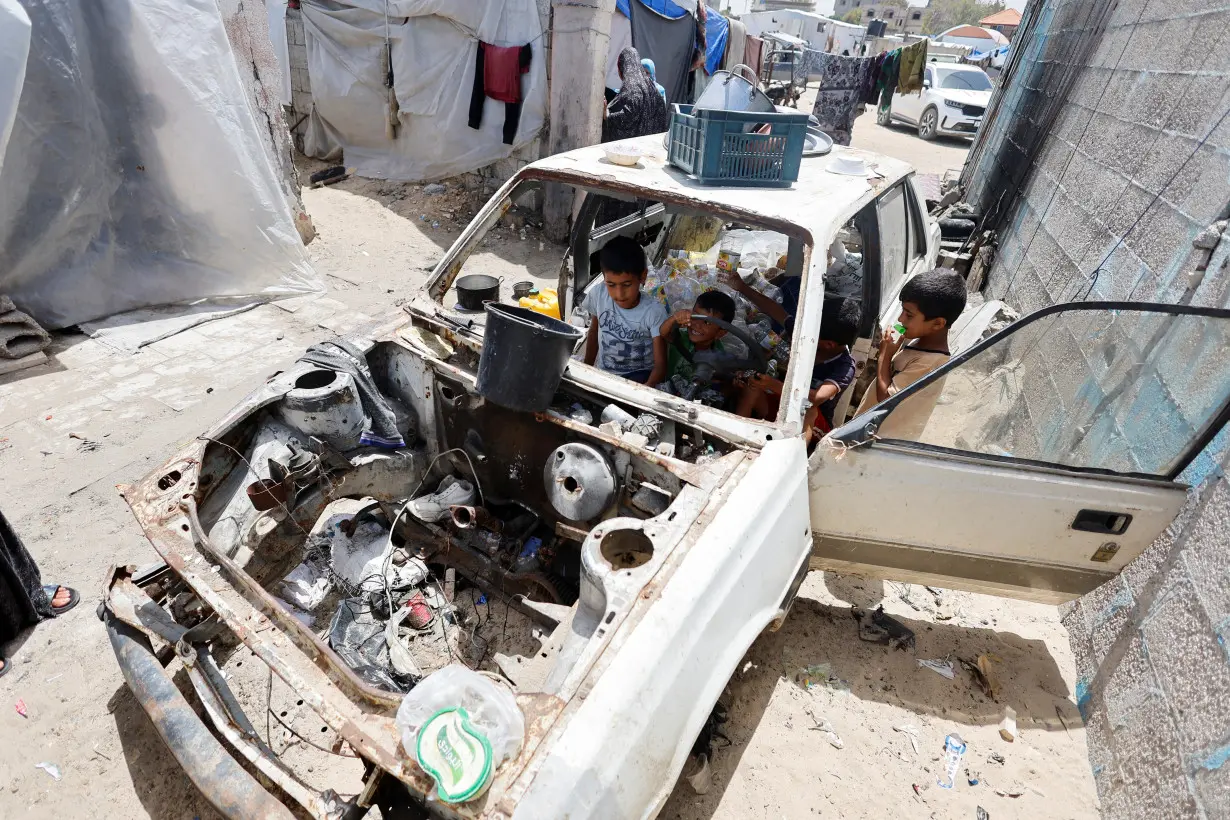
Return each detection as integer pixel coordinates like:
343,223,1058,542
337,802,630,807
808,302,1230,602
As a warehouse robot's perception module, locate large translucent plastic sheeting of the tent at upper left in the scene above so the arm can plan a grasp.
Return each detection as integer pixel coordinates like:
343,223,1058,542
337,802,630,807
0,0,321,327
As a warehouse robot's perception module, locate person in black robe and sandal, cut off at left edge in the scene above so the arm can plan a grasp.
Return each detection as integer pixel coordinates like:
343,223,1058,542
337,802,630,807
0,513,80,677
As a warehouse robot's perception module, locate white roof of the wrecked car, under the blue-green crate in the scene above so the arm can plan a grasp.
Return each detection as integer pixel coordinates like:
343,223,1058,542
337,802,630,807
518,134,914,245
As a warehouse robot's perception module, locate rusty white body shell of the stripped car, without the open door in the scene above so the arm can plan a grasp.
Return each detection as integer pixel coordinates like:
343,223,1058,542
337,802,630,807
103,138,1230,819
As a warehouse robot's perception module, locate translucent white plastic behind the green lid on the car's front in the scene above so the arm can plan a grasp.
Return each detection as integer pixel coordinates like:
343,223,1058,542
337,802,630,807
396,664,525,796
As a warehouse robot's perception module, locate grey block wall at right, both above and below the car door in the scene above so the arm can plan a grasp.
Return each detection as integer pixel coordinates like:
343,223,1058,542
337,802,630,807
966,0,1230,820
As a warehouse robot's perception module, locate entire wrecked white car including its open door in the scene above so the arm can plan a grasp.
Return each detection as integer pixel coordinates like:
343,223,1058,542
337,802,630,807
102,138,1230,820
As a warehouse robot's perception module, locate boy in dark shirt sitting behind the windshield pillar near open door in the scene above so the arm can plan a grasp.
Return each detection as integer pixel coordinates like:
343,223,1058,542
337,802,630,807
736,299,860,444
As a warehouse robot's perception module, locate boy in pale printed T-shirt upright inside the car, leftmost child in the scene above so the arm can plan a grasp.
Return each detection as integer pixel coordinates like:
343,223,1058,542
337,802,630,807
584,236,667,385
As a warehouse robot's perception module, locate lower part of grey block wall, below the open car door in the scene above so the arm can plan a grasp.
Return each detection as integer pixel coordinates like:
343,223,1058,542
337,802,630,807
1063,449,1230,820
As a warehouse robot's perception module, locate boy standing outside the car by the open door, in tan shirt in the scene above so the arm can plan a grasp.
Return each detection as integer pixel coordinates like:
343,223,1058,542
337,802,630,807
855,268,966,441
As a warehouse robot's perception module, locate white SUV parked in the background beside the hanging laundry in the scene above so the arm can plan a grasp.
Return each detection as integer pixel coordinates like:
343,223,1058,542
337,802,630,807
877,63,991,140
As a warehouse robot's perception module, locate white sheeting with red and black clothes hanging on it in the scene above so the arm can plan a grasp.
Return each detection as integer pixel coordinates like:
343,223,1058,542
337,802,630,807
301,0,547,182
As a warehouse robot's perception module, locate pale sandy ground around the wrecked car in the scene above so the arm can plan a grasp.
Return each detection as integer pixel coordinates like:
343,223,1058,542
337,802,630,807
0,117,1097,820
